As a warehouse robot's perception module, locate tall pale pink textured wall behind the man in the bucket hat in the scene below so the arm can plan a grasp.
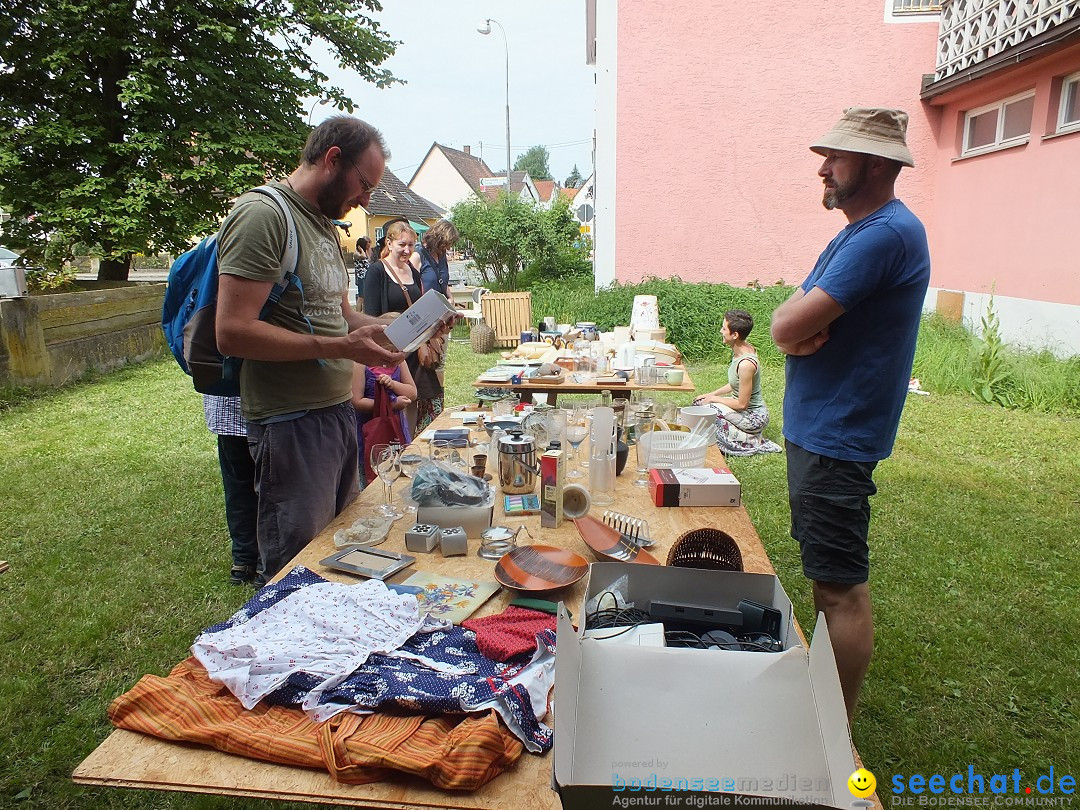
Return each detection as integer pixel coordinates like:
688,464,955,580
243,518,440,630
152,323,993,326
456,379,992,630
596,0,937,286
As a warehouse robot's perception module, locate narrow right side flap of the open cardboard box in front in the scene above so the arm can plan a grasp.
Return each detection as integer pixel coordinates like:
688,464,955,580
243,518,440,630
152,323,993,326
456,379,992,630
810,613,855,807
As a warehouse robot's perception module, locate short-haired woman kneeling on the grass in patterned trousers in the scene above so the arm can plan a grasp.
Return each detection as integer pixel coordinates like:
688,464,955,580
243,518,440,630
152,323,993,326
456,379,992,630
693,309,781,456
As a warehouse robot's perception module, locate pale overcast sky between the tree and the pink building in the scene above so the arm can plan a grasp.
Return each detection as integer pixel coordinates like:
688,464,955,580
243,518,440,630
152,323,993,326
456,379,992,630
311,0,594,183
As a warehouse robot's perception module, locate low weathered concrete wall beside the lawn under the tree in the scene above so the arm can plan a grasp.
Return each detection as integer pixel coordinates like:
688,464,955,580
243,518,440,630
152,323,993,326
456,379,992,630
0,283,165,386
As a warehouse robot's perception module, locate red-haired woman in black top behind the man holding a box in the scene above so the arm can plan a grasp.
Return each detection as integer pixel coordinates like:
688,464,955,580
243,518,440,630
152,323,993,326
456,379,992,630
364,221,443,436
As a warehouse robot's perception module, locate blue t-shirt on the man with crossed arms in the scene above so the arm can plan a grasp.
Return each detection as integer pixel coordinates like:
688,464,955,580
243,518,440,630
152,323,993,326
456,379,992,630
784,200,930,461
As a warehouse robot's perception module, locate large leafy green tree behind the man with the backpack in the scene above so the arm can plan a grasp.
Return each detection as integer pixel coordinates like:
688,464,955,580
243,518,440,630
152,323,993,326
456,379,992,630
0,0,397,280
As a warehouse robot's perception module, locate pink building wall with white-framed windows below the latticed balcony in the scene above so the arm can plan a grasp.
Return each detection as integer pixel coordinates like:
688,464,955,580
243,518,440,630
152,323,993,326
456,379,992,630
930,39,1080,324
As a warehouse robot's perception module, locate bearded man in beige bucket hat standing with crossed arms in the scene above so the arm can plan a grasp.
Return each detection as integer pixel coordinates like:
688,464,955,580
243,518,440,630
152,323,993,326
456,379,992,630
772,107,930,720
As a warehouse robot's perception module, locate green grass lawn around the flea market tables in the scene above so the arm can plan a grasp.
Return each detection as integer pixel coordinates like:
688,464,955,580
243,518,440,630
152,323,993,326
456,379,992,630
0,345,1080,808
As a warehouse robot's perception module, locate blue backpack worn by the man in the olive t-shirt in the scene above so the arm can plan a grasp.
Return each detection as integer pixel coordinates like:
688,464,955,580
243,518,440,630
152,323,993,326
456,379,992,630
161,186,300,396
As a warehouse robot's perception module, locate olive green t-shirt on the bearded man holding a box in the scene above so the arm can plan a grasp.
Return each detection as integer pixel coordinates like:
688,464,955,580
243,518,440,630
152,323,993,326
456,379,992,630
217,183,352,420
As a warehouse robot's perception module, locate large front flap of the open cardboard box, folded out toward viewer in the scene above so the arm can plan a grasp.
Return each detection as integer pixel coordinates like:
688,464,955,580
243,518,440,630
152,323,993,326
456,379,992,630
555,637,833,805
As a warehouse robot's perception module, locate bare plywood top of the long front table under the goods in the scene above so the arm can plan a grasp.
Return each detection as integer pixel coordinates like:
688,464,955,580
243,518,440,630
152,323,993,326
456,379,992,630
72,414,794,810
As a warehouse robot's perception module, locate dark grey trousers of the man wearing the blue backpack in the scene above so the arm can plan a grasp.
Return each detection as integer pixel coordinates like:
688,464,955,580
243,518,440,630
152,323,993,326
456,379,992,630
247,402,360,583
